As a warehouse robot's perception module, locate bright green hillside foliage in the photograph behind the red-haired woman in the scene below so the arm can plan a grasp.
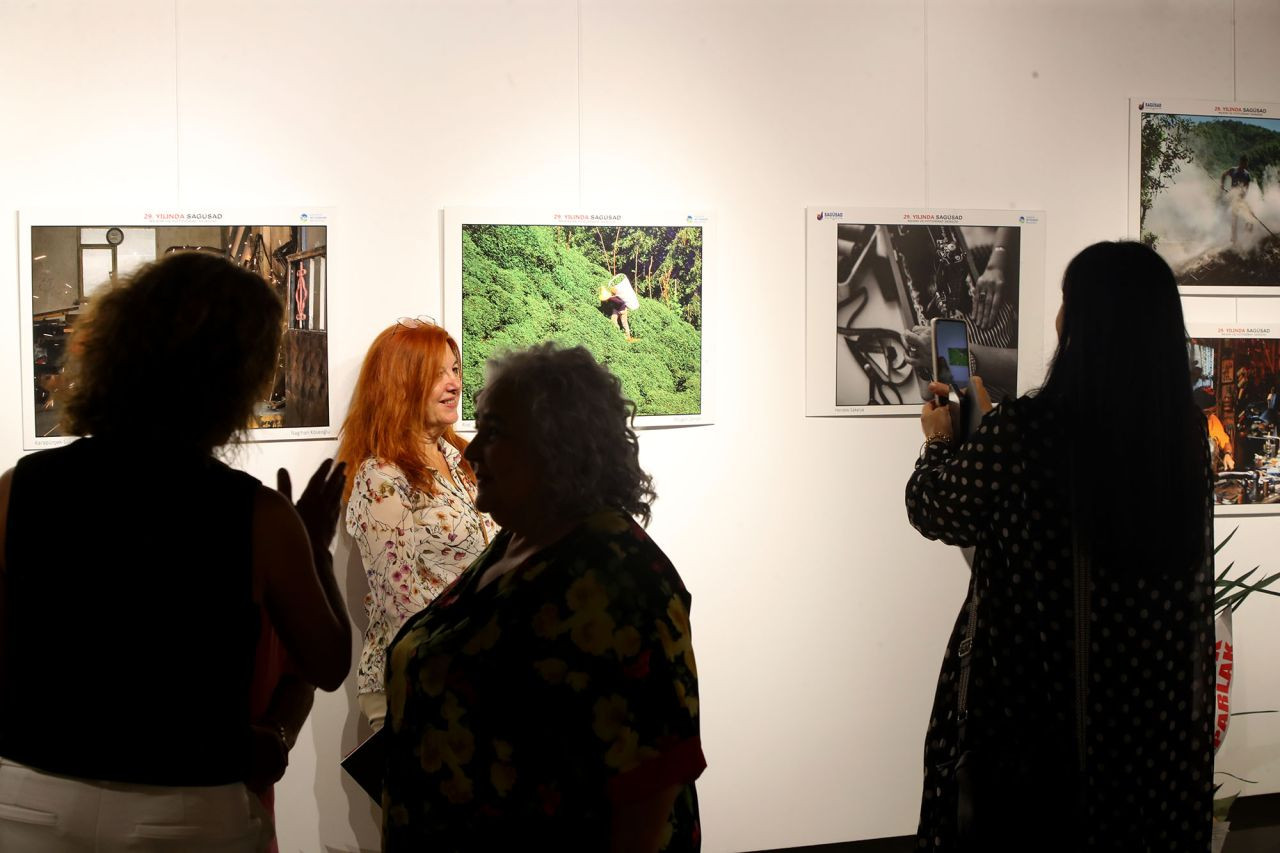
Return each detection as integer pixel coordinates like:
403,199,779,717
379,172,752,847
461,225,703,419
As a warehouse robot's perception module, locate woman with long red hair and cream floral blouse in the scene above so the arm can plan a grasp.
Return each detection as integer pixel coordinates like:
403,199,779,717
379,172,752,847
338,319,497,731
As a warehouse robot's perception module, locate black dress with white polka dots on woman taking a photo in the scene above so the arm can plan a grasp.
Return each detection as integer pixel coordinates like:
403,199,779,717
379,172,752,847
906,397,1213,853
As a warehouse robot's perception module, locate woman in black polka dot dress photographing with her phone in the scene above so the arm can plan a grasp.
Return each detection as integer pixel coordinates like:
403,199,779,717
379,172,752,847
906,242,1213,853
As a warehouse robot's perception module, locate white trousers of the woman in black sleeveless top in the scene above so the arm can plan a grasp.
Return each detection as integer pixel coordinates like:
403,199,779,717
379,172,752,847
0,758,270,853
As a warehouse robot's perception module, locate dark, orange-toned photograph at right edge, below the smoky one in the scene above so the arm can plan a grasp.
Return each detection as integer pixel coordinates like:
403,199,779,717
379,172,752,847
1188,327,1280,511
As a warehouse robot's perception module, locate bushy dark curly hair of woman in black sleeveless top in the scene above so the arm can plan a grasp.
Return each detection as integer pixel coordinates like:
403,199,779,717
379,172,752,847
61,252,284,452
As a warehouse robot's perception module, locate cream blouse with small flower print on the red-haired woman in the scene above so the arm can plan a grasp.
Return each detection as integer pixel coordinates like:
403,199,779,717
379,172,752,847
347,441,497,693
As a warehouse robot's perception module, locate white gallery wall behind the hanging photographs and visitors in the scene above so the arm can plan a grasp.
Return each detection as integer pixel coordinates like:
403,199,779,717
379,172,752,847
0,0,1280,852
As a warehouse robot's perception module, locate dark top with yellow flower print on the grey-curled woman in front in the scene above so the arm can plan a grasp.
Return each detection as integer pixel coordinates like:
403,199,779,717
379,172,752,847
383,511,707,853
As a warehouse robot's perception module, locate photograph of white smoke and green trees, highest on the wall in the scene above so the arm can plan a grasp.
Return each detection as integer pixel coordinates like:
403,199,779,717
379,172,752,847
1134,101,1280,292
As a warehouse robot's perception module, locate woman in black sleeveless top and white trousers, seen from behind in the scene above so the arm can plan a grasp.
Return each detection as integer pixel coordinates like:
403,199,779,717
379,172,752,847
0,252,351,852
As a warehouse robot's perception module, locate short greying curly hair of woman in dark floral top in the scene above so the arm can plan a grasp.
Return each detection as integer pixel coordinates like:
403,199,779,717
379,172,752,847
484,343,658,524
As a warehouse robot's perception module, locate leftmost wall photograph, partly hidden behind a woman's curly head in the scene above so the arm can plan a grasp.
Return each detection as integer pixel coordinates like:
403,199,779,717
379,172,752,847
23,216,332,447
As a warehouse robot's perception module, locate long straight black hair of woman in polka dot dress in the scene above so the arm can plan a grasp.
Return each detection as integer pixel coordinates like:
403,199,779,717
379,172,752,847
1041,242,1210,571
